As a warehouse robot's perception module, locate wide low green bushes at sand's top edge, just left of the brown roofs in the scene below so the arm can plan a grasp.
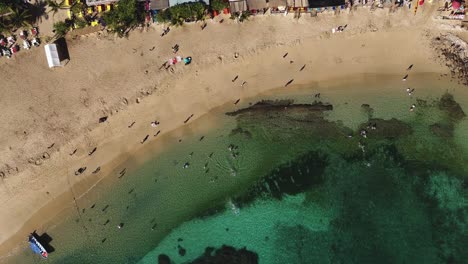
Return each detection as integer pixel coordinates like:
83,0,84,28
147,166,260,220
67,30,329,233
156,2,207,25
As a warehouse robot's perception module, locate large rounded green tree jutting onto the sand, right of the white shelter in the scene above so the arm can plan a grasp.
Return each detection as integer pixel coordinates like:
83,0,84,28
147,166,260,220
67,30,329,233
103,0,144,37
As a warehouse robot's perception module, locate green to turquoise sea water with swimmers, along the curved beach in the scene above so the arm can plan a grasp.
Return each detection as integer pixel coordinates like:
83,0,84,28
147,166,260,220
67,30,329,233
8,75,468,263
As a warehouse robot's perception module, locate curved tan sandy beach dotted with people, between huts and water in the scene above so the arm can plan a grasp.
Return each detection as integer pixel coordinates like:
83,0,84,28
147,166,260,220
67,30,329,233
0,2,466,262
